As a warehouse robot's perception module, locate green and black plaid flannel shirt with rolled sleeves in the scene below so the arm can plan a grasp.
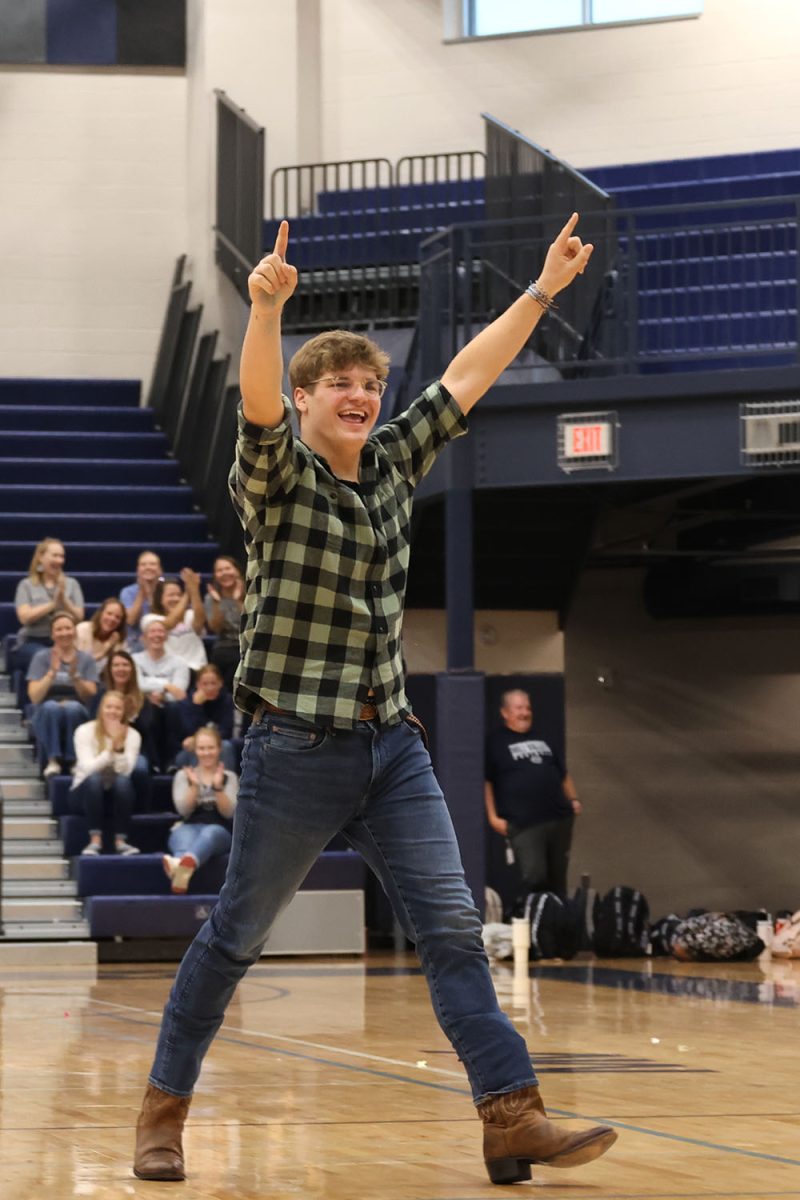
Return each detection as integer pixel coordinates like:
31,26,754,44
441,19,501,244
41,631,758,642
229,383,467,728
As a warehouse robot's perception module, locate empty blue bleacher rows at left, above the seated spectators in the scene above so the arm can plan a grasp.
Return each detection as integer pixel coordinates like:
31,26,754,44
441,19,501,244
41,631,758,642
0,379,217,636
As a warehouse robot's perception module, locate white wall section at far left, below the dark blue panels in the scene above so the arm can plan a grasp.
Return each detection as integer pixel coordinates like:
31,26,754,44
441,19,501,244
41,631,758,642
0,67,187,378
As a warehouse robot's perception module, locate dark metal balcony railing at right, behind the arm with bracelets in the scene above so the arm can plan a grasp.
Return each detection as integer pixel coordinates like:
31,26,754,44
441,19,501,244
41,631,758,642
421,196,800,379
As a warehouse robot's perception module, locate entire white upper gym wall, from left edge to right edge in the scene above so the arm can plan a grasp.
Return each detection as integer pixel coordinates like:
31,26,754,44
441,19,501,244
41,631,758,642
0,0,800,382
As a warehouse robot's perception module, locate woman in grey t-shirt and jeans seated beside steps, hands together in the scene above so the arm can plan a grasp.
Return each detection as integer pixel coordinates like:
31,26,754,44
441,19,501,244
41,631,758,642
26,612,97,779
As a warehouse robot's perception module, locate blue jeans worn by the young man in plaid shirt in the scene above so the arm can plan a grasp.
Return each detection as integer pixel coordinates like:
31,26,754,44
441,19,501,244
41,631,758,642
150,715,536,1100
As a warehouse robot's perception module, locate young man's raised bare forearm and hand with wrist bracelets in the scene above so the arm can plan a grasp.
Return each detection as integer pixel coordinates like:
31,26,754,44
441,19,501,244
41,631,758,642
441,212,594,413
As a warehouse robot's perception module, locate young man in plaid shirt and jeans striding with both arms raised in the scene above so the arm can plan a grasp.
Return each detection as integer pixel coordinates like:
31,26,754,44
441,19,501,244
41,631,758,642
134,214,616,1183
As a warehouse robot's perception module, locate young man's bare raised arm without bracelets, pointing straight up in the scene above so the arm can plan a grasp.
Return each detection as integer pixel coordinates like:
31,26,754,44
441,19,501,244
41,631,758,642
239,221,297,427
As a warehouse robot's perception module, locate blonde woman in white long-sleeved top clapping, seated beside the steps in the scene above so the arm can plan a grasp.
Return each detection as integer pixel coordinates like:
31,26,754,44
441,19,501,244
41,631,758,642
70,691,142,854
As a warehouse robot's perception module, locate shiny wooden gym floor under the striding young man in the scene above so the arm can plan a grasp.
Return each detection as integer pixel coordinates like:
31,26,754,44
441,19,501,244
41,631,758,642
0,954,800,1200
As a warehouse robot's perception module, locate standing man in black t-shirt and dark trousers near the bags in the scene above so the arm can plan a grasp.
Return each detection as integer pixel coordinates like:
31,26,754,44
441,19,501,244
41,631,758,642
485,690,581,896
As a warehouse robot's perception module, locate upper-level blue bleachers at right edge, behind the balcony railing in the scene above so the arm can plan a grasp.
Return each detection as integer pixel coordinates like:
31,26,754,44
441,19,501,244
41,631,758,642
585,150,800,371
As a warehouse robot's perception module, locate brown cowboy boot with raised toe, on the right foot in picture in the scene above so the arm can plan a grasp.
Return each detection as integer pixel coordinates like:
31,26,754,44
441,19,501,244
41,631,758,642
477,1087,616,1183
